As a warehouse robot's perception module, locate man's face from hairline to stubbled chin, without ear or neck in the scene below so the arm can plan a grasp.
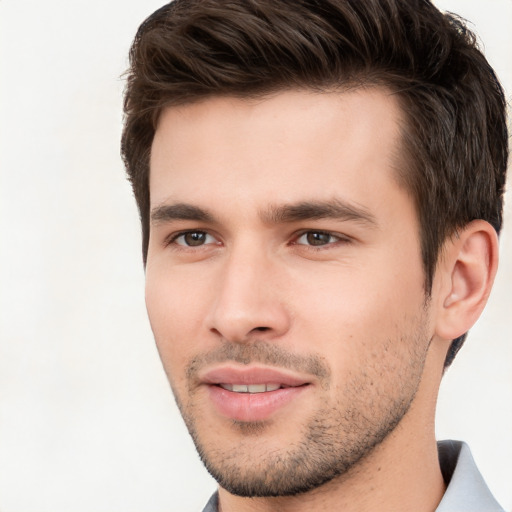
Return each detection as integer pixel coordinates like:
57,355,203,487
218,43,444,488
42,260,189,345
146,89,431,496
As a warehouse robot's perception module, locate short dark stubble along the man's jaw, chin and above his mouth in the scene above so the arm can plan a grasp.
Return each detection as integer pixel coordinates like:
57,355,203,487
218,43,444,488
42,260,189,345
167,329,430,497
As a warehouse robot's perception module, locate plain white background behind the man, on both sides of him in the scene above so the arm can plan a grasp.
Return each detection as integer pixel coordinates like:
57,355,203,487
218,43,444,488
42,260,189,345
0,0,512,512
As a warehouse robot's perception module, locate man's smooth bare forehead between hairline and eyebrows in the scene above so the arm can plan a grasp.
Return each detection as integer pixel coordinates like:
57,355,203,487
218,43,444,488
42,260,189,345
150,88,408,215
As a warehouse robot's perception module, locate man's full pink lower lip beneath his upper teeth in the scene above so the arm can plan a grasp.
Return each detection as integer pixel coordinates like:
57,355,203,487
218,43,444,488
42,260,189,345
208,385,309,422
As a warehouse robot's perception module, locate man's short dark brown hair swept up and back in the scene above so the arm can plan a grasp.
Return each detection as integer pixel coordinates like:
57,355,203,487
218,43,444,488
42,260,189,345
122,0,508,365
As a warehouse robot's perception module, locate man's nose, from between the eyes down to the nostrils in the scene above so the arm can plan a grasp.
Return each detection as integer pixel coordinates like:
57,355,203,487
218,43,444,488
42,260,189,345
207,247,290,343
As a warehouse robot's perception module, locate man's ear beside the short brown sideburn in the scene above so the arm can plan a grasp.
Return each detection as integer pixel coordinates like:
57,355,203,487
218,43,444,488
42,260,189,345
436,220,498,340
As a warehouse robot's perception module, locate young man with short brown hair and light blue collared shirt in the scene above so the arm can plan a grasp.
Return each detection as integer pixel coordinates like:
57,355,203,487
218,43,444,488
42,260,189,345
122,0,508,512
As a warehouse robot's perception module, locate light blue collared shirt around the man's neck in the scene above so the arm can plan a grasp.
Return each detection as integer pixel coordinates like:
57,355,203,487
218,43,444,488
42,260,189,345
203,441,505,512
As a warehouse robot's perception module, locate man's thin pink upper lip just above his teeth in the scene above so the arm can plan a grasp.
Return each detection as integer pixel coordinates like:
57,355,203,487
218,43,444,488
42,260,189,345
199,366,309,387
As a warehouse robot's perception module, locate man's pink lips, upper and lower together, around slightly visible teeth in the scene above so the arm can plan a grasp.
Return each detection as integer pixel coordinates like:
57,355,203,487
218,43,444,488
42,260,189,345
200,366,311,422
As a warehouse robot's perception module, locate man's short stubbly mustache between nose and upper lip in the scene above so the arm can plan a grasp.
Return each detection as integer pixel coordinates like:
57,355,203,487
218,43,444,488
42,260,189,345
186,340,331,385
